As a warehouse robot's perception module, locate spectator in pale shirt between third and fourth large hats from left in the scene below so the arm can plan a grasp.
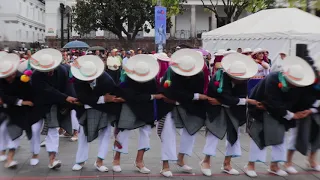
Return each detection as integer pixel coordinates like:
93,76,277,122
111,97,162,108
106,49,122,84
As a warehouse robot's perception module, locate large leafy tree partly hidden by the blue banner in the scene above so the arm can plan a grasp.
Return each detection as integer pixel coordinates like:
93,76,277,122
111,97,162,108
74,0,185,47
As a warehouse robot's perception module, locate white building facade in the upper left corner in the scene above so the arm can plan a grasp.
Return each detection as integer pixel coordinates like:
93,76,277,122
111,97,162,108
0,0,45,48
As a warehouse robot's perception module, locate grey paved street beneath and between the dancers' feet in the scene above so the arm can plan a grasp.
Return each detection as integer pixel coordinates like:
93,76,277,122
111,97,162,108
0,130,320,180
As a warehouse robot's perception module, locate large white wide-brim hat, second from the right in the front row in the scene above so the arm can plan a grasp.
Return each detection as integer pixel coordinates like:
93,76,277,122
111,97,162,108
221,53,258,80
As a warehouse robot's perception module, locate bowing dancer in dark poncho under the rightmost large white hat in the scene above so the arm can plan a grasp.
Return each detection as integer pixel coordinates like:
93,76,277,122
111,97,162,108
245,57,315,177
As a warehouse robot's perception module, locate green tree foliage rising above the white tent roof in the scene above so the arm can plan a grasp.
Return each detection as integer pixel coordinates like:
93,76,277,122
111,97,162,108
201,0,275,24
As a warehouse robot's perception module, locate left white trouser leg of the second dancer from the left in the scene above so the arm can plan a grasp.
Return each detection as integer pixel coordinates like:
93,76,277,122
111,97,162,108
30,120,43,155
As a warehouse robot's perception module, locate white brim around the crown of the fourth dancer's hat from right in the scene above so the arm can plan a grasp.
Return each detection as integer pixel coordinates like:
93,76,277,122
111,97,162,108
125,54,160,82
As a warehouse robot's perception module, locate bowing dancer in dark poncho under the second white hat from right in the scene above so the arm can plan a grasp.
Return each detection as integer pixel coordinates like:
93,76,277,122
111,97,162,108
200,53,258,176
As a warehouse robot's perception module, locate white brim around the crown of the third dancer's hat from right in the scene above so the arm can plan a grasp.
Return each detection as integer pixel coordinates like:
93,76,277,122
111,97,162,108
170,49,204,76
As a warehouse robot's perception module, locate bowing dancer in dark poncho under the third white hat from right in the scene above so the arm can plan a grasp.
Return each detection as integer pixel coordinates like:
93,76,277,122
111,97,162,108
157,49,207,177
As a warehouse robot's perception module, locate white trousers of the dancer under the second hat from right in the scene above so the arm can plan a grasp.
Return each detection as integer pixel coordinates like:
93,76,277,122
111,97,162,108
203,131,241,157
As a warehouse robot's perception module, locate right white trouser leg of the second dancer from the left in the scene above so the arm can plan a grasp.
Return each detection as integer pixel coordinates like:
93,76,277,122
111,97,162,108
46,128,59,153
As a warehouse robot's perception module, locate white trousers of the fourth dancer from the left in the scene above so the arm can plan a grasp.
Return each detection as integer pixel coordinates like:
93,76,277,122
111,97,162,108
113,125,151,154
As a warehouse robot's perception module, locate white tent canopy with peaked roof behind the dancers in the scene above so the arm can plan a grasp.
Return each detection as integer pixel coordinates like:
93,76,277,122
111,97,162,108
202,8,320,60
